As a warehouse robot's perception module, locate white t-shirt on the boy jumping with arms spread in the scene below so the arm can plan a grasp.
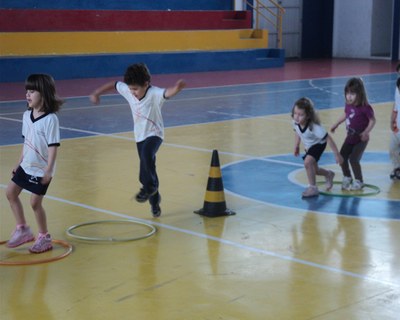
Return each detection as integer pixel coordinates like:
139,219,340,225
115,81,166,142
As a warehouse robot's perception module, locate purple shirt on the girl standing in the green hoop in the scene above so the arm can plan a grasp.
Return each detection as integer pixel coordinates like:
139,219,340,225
344,104,374,144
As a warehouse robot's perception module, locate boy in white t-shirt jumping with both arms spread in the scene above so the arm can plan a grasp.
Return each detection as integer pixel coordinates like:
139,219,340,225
90,63,186,217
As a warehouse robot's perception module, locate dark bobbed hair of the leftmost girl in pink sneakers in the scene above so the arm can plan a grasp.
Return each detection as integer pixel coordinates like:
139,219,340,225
25,74,64,113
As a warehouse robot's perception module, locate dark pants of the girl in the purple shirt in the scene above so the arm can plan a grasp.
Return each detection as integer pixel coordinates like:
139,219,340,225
340,141,368,182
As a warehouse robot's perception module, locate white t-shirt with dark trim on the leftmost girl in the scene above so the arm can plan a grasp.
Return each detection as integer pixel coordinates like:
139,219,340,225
20,110,60,177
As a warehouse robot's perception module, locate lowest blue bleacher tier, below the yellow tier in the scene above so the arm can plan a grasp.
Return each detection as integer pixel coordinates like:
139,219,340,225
0,49,284,82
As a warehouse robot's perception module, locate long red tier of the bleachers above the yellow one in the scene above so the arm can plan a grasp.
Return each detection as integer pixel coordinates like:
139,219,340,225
0,9,251,32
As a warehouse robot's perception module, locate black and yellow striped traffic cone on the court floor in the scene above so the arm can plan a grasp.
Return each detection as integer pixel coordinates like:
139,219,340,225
194,150,236,217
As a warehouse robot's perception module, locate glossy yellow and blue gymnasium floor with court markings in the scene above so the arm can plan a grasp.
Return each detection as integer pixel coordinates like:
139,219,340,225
0,60,400,320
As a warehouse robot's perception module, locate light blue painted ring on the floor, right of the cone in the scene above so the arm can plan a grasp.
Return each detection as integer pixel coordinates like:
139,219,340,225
222,152,400,220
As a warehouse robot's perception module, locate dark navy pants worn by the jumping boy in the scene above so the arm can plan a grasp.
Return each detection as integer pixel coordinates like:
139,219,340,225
136,136,162,194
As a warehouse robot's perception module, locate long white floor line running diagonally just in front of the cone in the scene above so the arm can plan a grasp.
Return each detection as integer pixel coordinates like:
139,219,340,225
0,184,400,287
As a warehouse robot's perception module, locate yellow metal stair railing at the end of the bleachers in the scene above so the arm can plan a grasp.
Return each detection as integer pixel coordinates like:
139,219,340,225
243,0,285,49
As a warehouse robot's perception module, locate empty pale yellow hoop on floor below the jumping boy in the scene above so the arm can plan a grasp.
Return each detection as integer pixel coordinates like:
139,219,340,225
66,219,157,242
